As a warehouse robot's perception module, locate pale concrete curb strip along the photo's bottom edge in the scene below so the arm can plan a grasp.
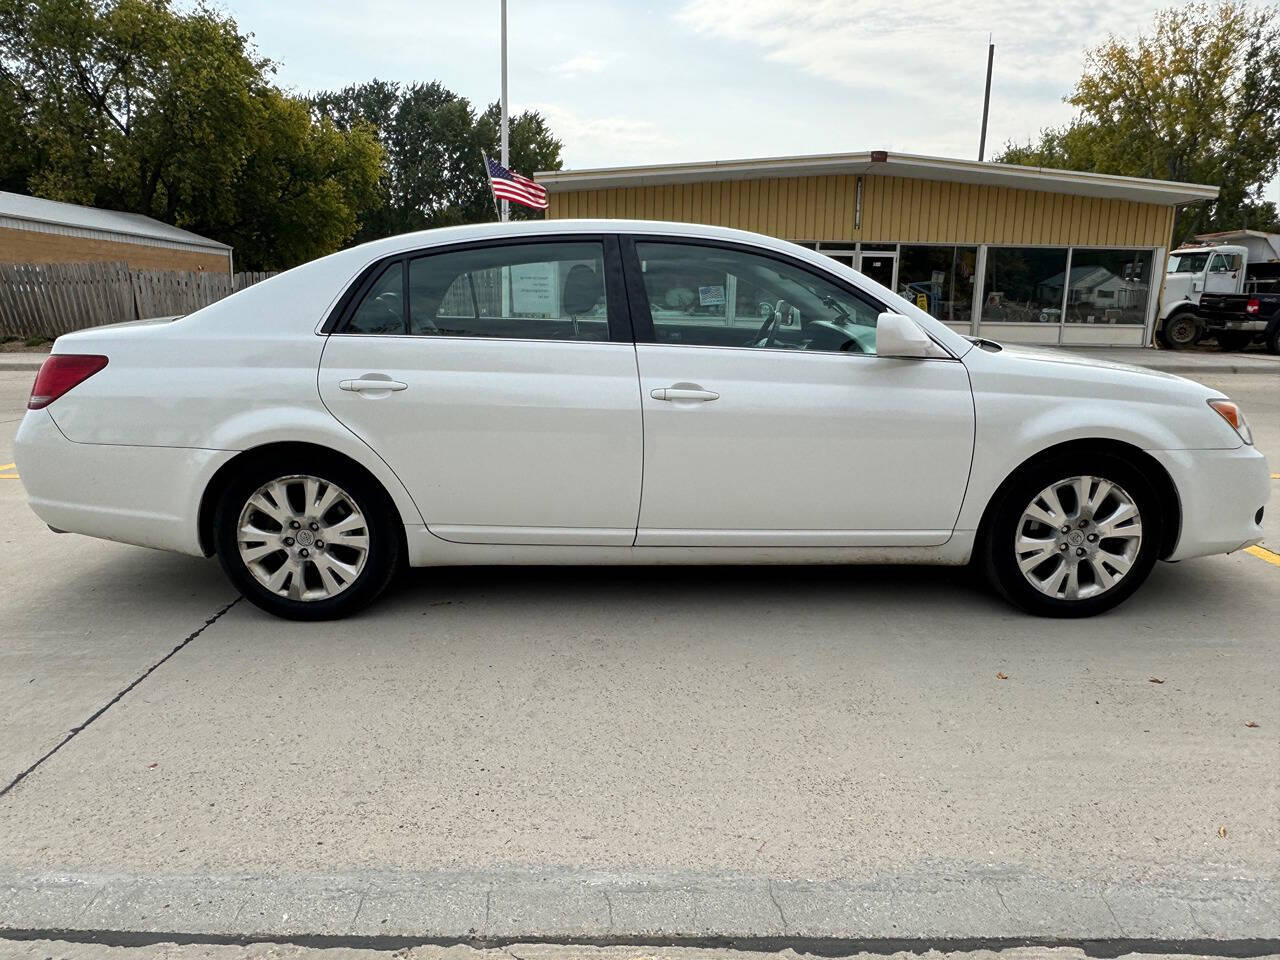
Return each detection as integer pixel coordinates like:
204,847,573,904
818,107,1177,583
0,869,1280,951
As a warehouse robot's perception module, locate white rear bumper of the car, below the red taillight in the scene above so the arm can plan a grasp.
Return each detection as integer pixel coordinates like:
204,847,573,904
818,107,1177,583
14,410,236,557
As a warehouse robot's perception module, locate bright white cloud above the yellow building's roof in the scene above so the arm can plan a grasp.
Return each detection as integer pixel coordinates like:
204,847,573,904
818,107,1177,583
676,0,1162,155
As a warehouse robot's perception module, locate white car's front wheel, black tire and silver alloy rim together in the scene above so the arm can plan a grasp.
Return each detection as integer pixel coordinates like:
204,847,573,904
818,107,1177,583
983,454,1162,617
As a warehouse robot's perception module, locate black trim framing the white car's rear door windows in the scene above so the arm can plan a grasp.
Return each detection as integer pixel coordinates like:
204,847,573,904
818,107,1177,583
319,233,635,344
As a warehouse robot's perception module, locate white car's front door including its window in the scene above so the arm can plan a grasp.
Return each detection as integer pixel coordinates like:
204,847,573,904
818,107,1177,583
623,238,974,547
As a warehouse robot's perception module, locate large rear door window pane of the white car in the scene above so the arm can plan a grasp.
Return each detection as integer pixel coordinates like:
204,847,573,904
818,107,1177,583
408,242,609,340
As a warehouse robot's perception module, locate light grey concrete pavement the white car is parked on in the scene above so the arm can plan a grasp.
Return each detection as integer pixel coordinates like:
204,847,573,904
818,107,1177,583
0,363,1280,946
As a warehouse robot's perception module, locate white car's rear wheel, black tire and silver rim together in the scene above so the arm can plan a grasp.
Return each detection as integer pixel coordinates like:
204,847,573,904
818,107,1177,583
214,457,401,620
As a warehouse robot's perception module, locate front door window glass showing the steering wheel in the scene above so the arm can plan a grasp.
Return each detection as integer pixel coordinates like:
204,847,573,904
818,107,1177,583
636,242,881,353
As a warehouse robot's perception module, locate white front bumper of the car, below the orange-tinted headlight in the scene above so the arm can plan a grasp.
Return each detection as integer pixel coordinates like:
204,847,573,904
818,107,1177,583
1148,445,1271,561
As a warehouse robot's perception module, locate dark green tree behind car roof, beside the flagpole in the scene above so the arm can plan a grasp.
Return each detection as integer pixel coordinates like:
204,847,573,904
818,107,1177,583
311,79,561,239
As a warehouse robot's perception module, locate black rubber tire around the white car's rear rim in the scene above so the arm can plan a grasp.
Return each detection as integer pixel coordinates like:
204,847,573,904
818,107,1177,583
214,454,403,621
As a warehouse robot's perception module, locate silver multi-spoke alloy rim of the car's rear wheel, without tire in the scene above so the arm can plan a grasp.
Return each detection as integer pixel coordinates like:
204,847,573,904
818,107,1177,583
237,474,369,600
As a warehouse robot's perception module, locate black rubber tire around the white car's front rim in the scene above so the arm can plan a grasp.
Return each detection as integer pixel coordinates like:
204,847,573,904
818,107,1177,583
979,452,1164,617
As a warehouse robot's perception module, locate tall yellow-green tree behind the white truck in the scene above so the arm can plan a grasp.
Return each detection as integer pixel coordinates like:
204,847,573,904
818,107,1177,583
997,0,1280,242
